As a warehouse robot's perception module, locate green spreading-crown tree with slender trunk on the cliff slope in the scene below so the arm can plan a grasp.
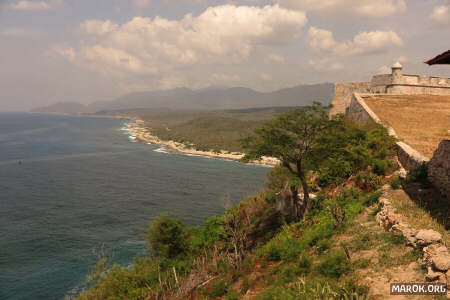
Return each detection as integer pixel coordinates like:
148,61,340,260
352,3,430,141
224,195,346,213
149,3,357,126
242,102,336,216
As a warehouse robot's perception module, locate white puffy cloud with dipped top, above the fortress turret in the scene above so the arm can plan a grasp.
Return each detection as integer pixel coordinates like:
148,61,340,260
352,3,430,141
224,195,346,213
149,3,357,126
307,27,403,56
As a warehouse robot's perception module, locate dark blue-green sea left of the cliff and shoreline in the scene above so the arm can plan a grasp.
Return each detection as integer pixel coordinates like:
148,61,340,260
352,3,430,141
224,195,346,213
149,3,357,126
0,113,270,300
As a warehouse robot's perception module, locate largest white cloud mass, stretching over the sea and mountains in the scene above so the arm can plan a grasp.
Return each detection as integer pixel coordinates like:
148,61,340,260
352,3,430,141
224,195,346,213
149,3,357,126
52,5,307,88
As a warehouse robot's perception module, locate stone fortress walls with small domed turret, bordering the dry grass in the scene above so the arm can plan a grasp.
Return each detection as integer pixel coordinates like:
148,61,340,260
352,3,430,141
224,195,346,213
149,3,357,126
330,63,450,199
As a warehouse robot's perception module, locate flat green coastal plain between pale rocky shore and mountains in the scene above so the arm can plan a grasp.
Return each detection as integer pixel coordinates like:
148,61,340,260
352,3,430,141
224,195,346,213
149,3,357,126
134,107,295,152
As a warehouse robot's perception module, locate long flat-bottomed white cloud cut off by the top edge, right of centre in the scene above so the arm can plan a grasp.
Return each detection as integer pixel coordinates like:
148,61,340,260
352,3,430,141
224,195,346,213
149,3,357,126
274,0,406,18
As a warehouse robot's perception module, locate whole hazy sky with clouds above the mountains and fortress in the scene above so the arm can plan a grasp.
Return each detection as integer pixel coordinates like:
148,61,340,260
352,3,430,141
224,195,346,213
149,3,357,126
0,0,450,111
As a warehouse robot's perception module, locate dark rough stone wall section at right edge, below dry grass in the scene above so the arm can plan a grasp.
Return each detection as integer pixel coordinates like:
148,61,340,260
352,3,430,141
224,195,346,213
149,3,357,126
428,140,450,199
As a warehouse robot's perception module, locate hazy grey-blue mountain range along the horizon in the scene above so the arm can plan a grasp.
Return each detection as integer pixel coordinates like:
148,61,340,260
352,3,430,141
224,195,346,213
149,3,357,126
32,83,334,114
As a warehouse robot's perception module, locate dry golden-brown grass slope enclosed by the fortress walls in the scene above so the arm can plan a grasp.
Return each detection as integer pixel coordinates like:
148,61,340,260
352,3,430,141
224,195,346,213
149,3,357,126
363,95,450,157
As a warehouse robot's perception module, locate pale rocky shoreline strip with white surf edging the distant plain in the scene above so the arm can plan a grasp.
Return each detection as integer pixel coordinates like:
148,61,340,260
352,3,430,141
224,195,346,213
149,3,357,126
124,119,280,166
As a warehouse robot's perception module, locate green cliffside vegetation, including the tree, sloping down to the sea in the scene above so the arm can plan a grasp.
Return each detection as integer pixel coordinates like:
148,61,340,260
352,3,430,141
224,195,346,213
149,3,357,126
79,104,404,299
